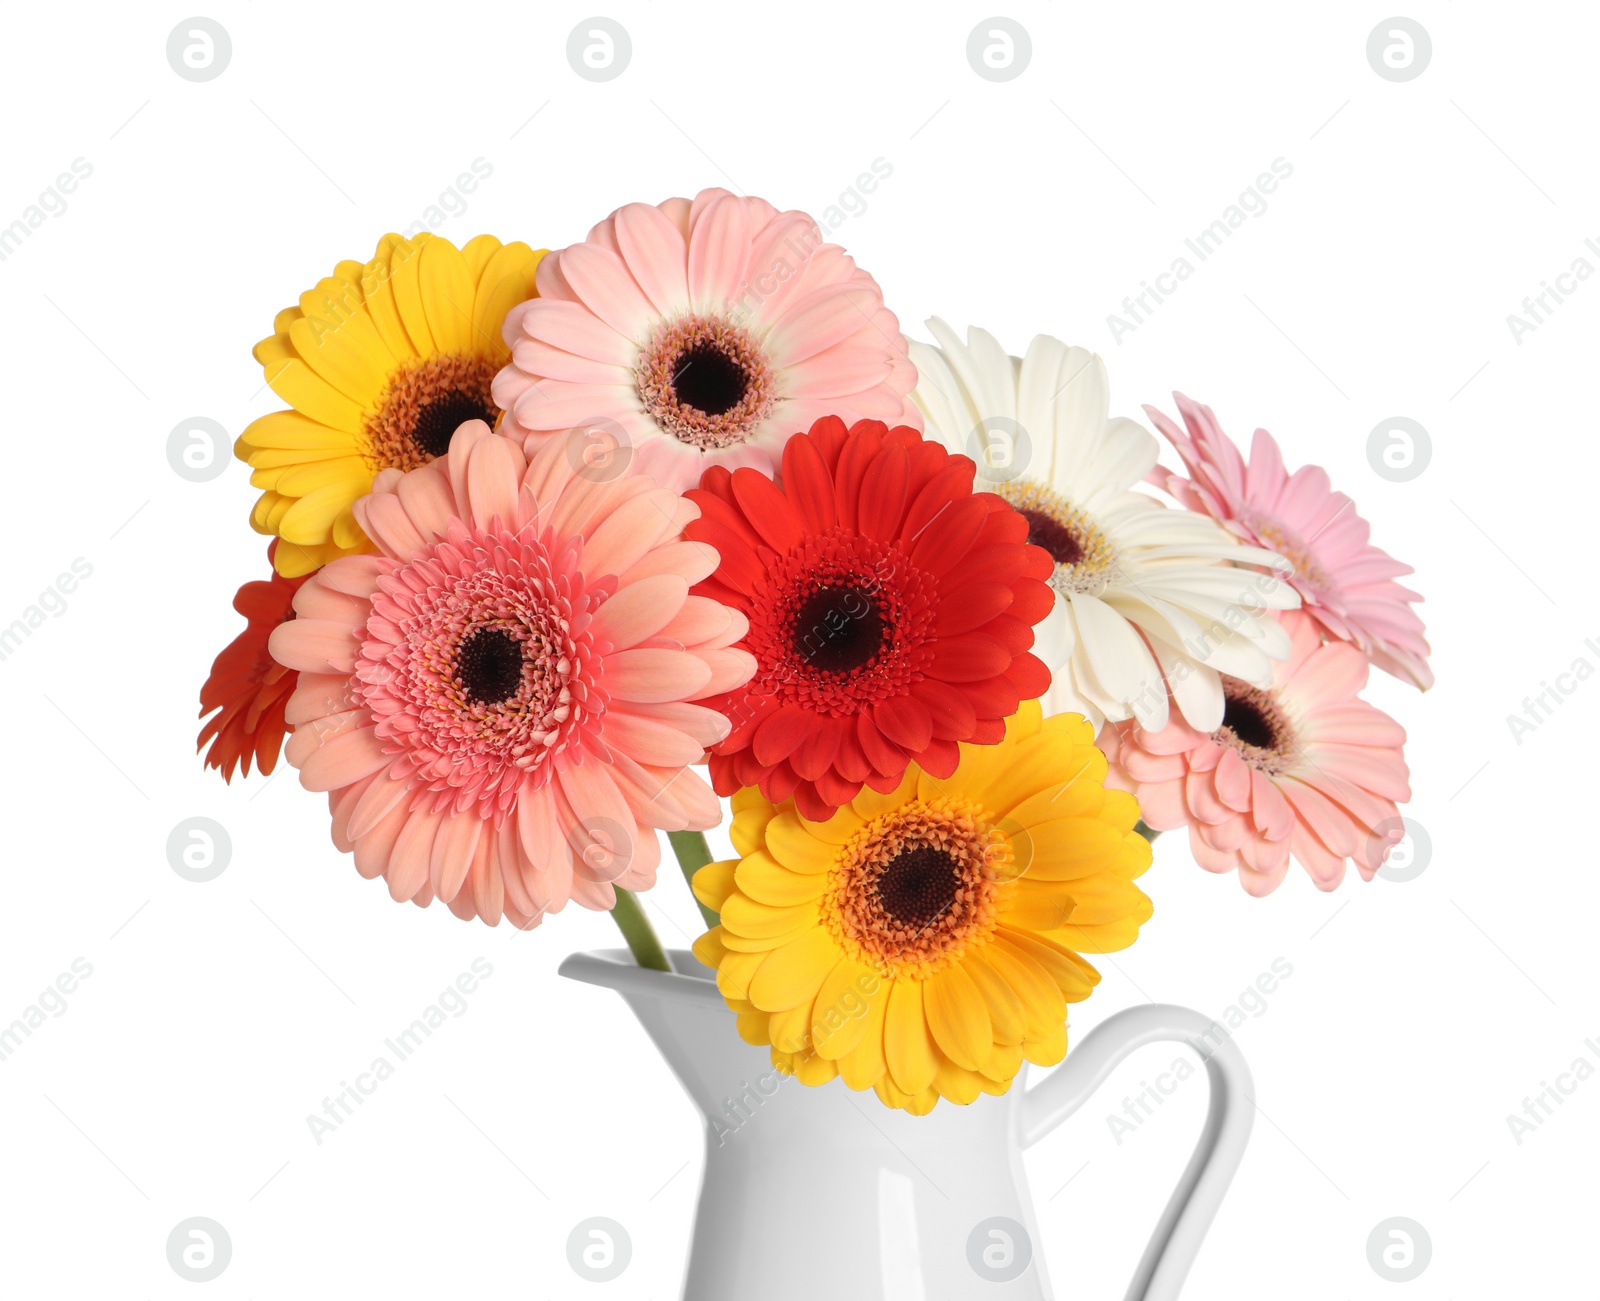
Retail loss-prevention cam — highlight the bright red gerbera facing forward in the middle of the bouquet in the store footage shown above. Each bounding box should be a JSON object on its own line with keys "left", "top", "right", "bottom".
{"left": 685, "top": 418, "right": 1051, "bottom": 819}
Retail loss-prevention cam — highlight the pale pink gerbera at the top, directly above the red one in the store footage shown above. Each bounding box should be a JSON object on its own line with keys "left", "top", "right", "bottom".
{"left": 493, "top": 189, "right": 917, "bottom": 490}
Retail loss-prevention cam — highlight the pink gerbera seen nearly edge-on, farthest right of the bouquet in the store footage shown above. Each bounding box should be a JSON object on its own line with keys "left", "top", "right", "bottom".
{"left": 1144, "top": 394, "right": 1434, "bottom": 690}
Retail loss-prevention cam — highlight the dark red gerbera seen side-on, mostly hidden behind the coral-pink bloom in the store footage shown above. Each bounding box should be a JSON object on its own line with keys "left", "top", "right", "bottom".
{"left": 195, "top": 539, "right": 304, "bottom": 781}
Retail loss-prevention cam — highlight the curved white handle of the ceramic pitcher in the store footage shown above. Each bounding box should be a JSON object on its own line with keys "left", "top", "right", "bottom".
{"left": 1021, "top": 1003, "right": 1256, "bottom": 1301}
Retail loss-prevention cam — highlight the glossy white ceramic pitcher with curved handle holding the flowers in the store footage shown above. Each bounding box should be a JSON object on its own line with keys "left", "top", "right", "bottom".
{"left": 560, "top": 949, "right": 1254, "bottom": 1301}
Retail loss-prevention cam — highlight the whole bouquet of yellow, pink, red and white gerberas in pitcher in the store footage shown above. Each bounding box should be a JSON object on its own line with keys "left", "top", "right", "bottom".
{"left": 200, "top": 182, "right": 1430, "bottom": 1114}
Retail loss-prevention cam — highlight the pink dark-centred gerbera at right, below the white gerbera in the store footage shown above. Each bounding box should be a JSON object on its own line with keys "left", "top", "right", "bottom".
{"left": 1098, "top": 610, "right": 1411, "bottom": 895}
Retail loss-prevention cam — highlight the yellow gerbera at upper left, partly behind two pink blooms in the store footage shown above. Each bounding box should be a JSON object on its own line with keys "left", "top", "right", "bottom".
{"left": 234, "top": 230, "right": 544, "bottom": 576}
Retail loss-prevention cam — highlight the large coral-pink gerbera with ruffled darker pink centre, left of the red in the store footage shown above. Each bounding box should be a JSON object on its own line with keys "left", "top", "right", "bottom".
{"left": 270, "top": 421, "right": 755, "bottom": 927}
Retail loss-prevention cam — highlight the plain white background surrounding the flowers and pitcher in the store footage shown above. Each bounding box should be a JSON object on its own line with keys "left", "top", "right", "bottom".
{"left": 0, "top": 0, "right": 1600, "bottom": 1301}
